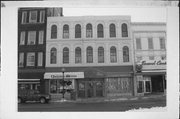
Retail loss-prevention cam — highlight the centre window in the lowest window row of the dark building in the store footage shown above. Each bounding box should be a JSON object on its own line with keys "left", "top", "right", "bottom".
{"left": 26, "top": 52, "right": 35, "bottom": 66}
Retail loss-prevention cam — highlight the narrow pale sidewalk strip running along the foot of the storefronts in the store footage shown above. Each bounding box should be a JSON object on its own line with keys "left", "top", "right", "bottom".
{"left": 50, "top": 94, "right": 166, "bottom": 103}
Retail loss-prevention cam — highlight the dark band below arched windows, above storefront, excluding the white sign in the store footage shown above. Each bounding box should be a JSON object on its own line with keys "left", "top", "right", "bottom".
{"left": 46, "top": 66, "right": 133, "bottom": 78}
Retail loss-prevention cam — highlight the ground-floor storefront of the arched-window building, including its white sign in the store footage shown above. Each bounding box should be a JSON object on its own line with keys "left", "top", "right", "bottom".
{"left": 44, "top": 66, "right": 133, "bottom": 99}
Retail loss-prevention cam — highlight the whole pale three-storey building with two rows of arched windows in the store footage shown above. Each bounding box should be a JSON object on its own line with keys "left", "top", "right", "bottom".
{"left": 44, "top": 16, "right": 134, "bottom": 99}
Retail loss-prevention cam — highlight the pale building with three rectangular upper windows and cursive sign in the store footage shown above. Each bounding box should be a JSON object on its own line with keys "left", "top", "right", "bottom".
{"left": 132, "top": 22, "right": 166, "bottom": 95}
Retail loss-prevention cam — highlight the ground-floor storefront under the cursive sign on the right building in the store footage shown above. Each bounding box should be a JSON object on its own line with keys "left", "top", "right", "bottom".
{"left": 135, "top": 61, "right": 166, "bottom": 95}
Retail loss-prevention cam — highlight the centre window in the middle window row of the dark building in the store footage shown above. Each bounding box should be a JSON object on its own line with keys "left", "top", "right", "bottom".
{"left": 27, "top": 31, "right": 36, "bottom": 45}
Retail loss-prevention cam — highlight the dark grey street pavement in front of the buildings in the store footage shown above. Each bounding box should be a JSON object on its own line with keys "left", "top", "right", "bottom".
{"left": 18, "top": 96, "right": 166, "bottom": 112}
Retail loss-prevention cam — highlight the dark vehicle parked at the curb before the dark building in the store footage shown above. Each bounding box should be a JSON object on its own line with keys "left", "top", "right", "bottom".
{"left": 18, "top": 89, "right": 51, "bottom": 103}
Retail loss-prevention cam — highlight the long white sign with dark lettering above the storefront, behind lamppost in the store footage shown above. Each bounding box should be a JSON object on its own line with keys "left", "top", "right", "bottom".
{"left": 44, "top": 72, "right": 84, "bottom": 79}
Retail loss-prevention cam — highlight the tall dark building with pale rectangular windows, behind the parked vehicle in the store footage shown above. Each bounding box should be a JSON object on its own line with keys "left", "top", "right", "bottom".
{"left": 18, "top": 7, "right": 62, "bottom": 93}
